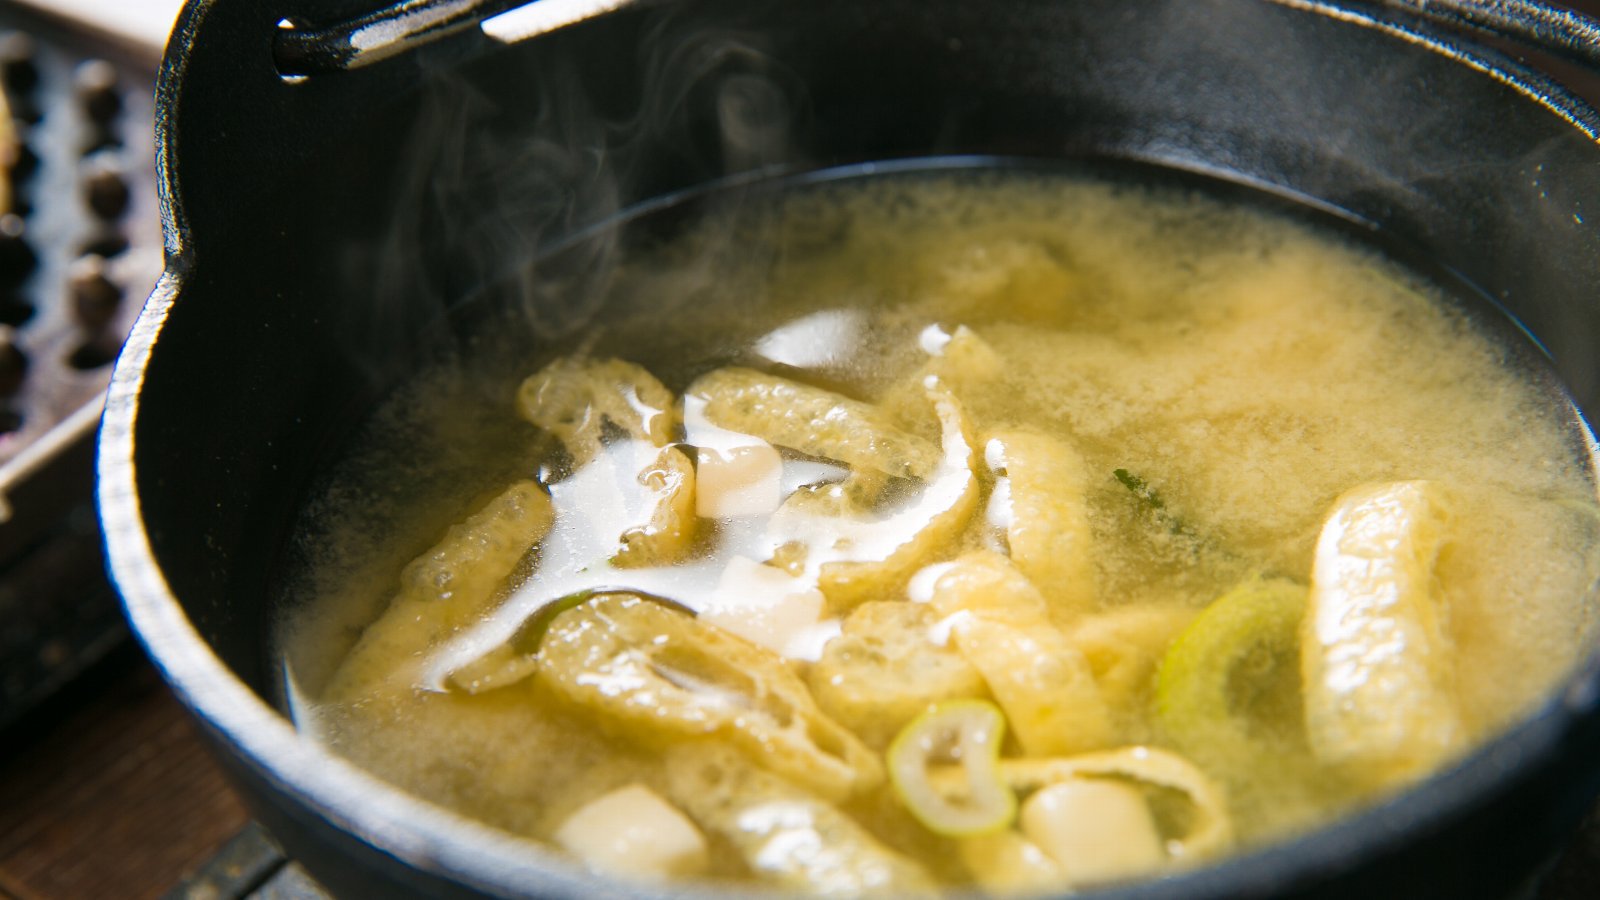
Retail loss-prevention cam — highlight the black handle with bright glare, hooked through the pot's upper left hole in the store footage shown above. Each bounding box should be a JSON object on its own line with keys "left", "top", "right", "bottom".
{"left": 272, "top": 0, "right": 627, "bottom": 78}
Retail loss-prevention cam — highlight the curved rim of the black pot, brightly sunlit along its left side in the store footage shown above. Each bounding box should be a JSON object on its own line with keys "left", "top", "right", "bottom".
{"left": 96, "top": 0, "right": 1600, "bottom": 900}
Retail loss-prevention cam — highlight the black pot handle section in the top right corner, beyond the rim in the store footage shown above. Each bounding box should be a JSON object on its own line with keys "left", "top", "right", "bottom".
{"left": 1382, "top": 0, "right": 1600, "bottom": 69}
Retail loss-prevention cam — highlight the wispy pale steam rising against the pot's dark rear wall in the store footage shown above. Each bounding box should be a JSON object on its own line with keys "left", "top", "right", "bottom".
{"left": 344, "top": 19, "right": 808, "bottom": 384}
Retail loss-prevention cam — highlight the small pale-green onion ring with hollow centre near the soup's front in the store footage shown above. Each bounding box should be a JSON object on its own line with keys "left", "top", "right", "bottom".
{"left": 888, "top": 700, "right": 1016, "bottom": 838}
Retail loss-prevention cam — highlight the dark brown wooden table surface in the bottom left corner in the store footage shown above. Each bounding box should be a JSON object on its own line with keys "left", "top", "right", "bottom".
{"left": 0, "top": 644, "right": 248, "bottom": 900}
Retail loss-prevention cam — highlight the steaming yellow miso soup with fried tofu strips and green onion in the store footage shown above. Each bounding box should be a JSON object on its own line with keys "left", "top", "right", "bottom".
{"left": 282, "top": 171, "right": 1600, "bottom": 895}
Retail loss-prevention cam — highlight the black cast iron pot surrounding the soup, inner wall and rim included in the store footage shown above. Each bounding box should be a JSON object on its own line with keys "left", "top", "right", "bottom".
{"left": 99, "top": 0, "right": 1600, "bottom": 898}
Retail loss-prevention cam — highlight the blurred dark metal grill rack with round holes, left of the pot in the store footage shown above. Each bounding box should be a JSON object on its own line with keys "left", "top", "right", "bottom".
{"left": 0, "top": 5, "right": 162, "bottom": 732}
